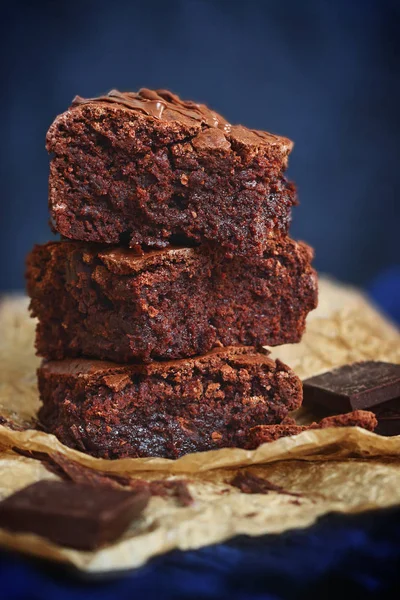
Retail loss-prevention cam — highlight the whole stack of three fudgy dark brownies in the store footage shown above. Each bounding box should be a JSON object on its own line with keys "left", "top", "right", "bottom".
{"left": 27, "top": 89, "right": 317, "bottom": 458}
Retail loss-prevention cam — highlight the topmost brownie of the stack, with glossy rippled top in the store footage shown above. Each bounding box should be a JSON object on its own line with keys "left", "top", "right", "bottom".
{"left": 47, "top": 89, "right": 296, "bottom": 255}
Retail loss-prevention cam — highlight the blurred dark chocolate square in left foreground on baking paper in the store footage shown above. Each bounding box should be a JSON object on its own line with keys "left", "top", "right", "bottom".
{"left": 0, "top": 481, "right": 149, "bottom": 550}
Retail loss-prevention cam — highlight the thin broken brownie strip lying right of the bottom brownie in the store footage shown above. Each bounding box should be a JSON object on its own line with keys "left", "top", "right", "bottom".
{"left": 246, "top": 410, "right": 378, "bottom": 449}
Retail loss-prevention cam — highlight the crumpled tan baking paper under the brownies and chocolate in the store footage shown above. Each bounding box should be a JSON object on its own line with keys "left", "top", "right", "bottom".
{"left": 0, "top": 279, "right": 400, "bottom": 573}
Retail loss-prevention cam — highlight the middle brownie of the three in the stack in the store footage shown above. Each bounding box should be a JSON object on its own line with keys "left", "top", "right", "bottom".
{"left": 27, "top": 238, "right": 317, "bottom": 362}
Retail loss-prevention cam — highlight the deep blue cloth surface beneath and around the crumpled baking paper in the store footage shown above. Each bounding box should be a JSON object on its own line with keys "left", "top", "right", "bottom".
{"left": 0, "top": 278, "right": 400, "bottom": 600}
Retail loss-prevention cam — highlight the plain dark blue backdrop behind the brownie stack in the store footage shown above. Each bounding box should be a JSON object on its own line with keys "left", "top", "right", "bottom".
{"left": 0, "top": 0, "right": 400, "bottom": 289}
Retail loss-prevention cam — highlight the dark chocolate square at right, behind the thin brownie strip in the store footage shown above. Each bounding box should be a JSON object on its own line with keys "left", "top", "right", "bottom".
{"left": 303, "top": 361, "right": 400, "bottom": 412}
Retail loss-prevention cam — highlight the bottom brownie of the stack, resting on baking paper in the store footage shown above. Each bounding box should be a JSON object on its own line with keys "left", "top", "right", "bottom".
{"left": 38, "top": 347, "right": 302, "bottom": 458}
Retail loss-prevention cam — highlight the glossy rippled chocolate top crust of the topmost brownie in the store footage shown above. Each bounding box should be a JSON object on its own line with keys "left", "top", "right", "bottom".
{"left": 72, "top": 88, "right": 293, "bottom": 153}
